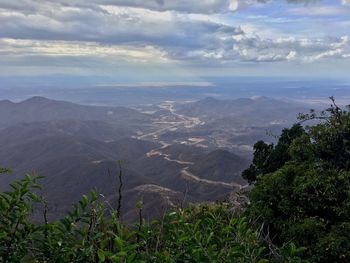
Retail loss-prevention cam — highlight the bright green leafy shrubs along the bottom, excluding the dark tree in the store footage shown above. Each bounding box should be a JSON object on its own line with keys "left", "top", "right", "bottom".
{"left": 0, "top": 176, "right": 306, "bottom": 263}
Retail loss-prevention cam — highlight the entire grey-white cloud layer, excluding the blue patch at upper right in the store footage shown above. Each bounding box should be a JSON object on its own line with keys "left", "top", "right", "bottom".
{"left": 0, "top": 0, "right": 350, "bottom": 72}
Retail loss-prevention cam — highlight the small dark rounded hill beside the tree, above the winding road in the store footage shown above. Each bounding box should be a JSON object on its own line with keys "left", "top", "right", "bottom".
{"left": 189, "top": 150, "right": 250, "bottom": 185}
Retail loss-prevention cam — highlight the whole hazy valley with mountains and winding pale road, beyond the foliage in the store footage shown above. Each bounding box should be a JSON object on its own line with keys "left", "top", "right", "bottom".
{"left": 0, "top": 97, "right": 318, "bottom": 221}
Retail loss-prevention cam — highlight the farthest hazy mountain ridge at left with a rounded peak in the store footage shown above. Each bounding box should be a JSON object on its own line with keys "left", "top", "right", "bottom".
{"left": 0, "top": 97, "right": 150, "bottom": 128}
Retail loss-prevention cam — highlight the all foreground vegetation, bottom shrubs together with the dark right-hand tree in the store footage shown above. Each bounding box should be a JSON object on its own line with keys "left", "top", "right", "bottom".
{"left": 0, "top": 98, "right": 350, "bottom": 263}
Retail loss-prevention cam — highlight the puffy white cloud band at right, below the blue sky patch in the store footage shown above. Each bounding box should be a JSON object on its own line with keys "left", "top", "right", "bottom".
{"left": 182, "top": 33, "right": 350, "bottom": 63}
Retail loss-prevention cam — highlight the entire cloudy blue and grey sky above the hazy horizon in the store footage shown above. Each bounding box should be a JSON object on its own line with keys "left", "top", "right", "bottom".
{"left": 0, "top": 0, "right": 350, "bottom": 85}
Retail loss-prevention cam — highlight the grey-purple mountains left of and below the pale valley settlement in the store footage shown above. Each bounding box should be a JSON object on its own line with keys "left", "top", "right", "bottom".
{"left": 0, "top": 97, "right": 254, "bottom": 221}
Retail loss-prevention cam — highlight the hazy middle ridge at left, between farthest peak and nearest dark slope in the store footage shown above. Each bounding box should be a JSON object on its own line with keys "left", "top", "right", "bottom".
{"left": 0, "top": 130, "right": 159, "bottom": 183}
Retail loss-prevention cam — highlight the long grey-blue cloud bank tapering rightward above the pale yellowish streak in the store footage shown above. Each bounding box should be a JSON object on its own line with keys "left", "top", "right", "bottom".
{"left": 0, "top": 3, "right": 240, "bottom": 50}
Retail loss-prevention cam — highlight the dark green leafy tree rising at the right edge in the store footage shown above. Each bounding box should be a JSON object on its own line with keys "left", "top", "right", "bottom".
{"left": 246, "top": 98, "right": 350, "bottom": 263}
